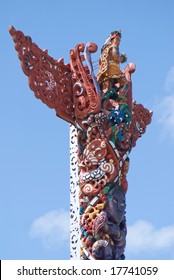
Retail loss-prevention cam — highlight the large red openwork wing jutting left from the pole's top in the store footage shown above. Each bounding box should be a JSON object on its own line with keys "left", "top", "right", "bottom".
{"left": 9, "top": 26, "right": 75, "bottom": 124}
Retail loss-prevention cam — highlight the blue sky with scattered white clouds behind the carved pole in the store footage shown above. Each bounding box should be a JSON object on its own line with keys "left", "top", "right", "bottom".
{"left": 0, "top": 0, "right": 174, "bottom": 260}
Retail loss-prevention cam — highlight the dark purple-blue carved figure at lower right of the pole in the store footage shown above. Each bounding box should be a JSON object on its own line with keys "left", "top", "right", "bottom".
{"left": 92, "top": 184, "right": 127, "bottom": 260}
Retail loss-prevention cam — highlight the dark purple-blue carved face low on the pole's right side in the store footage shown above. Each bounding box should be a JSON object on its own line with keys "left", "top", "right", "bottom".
{"left": 108, "top": 187, "right": 126, "bottom": 224}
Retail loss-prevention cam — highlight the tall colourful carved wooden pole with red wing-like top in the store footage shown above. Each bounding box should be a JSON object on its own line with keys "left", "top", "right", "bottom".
{"left": 9, "top": 26, "right": 152, "bottom": 260}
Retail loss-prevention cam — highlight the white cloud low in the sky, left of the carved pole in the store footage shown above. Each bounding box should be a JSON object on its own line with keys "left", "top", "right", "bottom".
{"left": 30, "top": 210, "right": 70, "bottom": 249}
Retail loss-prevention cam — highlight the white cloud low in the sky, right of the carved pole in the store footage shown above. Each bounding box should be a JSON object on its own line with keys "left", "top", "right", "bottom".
{"left": 126, "top": 220, "right": 174, "bottom": 255}
